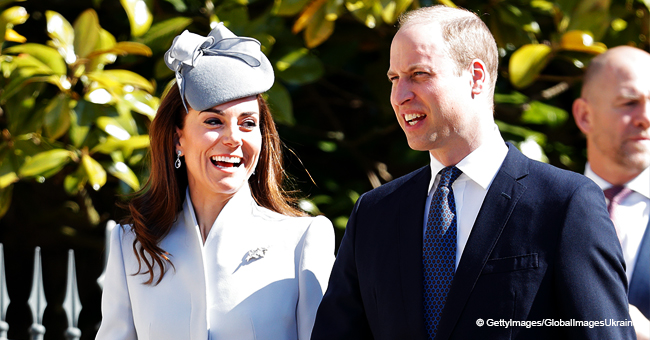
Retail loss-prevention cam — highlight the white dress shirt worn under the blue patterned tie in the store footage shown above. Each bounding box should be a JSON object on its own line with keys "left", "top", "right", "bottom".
{"left": 424, "top": 125, "right": 508, "bottom": 268}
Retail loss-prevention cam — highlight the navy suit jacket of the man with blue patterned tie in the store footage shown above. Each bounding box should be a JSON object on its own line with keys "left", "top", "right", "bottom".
{"left": 312, "top": 145, "right": 635, "bottom": 340}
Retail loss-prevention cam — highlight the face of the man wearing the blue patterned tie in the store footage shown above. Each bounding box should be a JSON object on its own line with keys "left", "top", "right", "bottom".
{"left": 388, "top": 24, "right": 478, "bottom": 152}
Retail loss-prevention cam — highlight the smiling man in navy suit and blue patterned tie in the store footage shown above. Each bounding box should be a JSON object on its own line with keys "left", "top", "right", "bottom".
{"left": 312, "top": 6, "right": 634, "bottom": 340}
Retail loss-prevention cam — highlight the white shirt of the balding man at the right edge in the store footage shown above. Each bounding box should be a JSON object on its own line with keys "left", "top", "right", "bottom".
{"left": 585, "top": 163, "right": 650, "bottom": 282}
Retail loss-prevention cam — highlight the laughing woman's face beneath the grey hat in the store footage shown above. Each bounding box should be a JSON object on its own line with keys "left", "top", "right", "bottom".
{"left": 176, "top": 96, "right": 262, "bottom": 199}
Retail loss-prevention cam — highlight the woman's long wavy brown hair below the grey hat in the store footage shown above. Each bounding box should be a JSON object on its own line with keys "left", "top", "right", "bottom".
{"left": 123, "top": 84, "right": 306, "bottom": 284}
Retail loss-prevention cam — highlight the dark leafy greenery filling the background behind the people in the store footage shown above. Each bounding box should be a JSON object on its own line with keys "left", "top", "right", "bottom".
{"left": 0, "top": 0, "right": 650, "bottom": 339}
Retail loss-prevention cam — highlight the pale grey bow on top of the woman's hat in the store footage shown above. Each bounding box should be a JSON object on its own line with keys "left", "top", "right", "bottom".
{"left": 165, "top": 23, "right": 262, "bottom": 112}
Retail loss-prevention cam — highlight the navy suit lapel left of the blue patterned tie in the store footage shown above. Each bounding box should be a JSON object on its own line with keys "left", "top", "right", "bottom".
{"left": 397, "top": 166, "right": 431, "bottom": 339}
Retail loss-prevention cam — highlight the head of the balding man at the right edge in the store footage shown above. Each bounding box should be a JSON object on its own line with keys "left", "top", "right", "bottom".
{"left": 584, "top": 58, "right": 650, "bottom": 173}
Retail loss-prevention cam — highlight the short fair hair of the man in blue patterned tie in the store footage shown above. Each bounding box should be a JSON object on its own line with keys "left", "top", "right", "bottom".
{"left": 399, "top": 5, "right": 499, "bottom": 91}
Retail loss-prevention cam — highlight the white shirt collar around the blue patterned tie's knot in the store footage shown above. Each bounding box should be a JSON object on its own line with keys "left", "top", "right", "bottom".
{"left": 429, "top": 124, "right": 508, "bottom": 192}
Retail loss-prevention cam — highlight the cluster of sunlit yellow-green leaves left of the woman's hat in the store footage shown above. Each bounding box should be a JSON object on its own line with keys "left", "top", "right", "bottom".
{"left": 0, "top": 1, "right": 156, "bottom": 218}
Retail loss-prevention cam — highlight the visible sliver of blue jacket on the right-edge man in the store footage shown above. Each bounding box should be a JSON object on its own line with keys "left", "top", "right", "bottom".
{"left": 628, "top": 222, "right": 650, "bottom": 318}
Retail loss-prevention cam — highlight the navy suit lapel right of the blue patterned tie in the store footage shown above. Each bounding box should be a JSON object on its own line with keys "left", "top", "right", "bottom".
{"left": 436, "top": 144, "right": 529, "bottom": 340}
